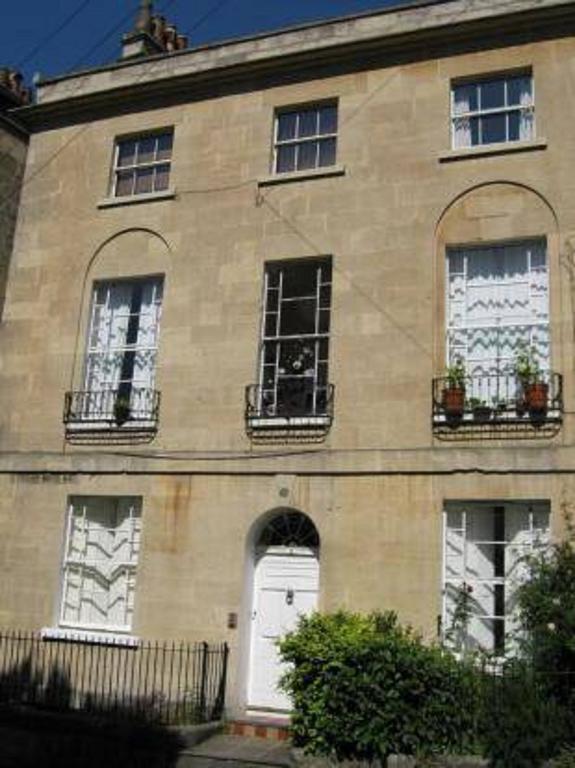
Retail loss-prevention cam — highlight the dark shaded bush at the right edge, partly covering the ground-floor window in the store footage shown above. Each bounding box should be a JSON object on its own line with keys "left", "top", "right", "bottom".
{"left": 482, "top": 518, "right": 575, "bottom": 768}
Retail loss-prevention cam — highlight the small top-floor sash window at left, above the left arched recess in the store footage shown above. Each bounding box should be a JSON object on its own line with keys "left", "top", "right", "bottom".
{"left": 112, "top": 131, "right": 174, "bottom": 197}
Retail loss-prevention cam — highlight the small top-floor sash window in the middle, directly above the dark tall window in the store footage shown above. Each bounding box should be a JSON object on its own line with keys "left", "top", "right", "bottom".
{"left": 274, "top": 102, "right": 337, "bottom": 173}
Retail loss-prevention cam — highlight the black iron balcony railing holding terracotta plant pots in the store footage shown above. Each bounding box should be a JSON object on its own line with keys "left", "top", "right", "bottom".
{"left": 432, "top": 371, "right": 563, "bottom": 436}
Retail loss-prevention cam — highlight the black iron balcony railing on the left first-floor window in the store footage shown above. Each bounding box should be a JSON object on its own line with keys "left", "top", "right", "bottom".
{"left": 64, "top": 387, "right": 160, "bottom": 432}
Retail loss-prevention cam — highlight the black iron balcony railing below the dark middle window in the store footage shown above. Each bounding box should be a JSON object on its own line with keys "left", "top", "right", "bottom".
{"left": 245, "top": 378, "right": 334, "bottom": 430}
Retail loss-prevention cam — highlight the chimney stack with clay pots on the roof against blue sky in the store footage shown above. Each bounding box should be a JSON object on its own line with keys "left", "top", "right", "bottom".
{"left": 121, "top": 0, "right": 188, "bottom": 61}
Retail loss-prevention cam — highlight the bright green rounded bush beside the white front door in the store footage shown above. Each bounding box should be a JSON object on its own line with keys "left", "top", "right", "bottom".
{"left": 280, "top": 612, "right": 477, "bottom": 760}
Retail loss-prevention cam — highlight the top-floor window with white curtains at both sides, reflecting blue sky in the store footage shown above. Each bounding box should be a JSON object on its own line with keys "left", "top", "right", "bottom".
{"left": 451, "top": 73, "right": 535, "bottom": 149}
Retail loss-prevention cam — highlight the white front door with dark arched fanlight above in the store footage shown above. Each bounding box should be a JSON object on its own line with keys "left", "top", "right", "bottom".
{"left": 244, "top": 507, "right": 320, "bottom": 713}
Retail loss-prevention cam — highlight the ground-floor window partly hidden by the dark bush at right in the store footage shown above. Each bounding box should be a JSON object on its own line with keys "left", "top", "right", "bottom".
{"left": 443, "top": 501, "right": 550, "bottom": 655}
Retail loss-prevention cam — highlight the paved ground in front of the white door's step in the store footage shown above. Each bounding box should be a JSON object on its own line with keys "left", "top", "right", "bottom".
{"left": 177, "top": 735, "right": 292, "bottom": 768}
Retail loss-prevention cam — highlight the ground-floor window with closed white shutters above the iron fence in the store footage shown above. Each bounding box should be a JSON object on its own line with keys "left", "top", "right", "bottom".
{"left": 60, "top": 496, "right": 142, "bottom": 631}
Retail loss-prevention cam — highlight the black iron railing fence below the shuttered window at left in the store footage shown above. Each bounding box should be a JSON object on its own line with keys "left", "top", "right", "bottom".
{"left": 0, "top": 631, "right": 229, "bottom": 725}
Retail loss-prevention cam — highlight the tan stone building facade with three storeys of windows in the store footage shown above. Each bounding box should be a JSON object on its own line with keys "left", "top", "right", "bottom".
{"left": 0, "top": 0, "right": 575, "bottom": 712}
